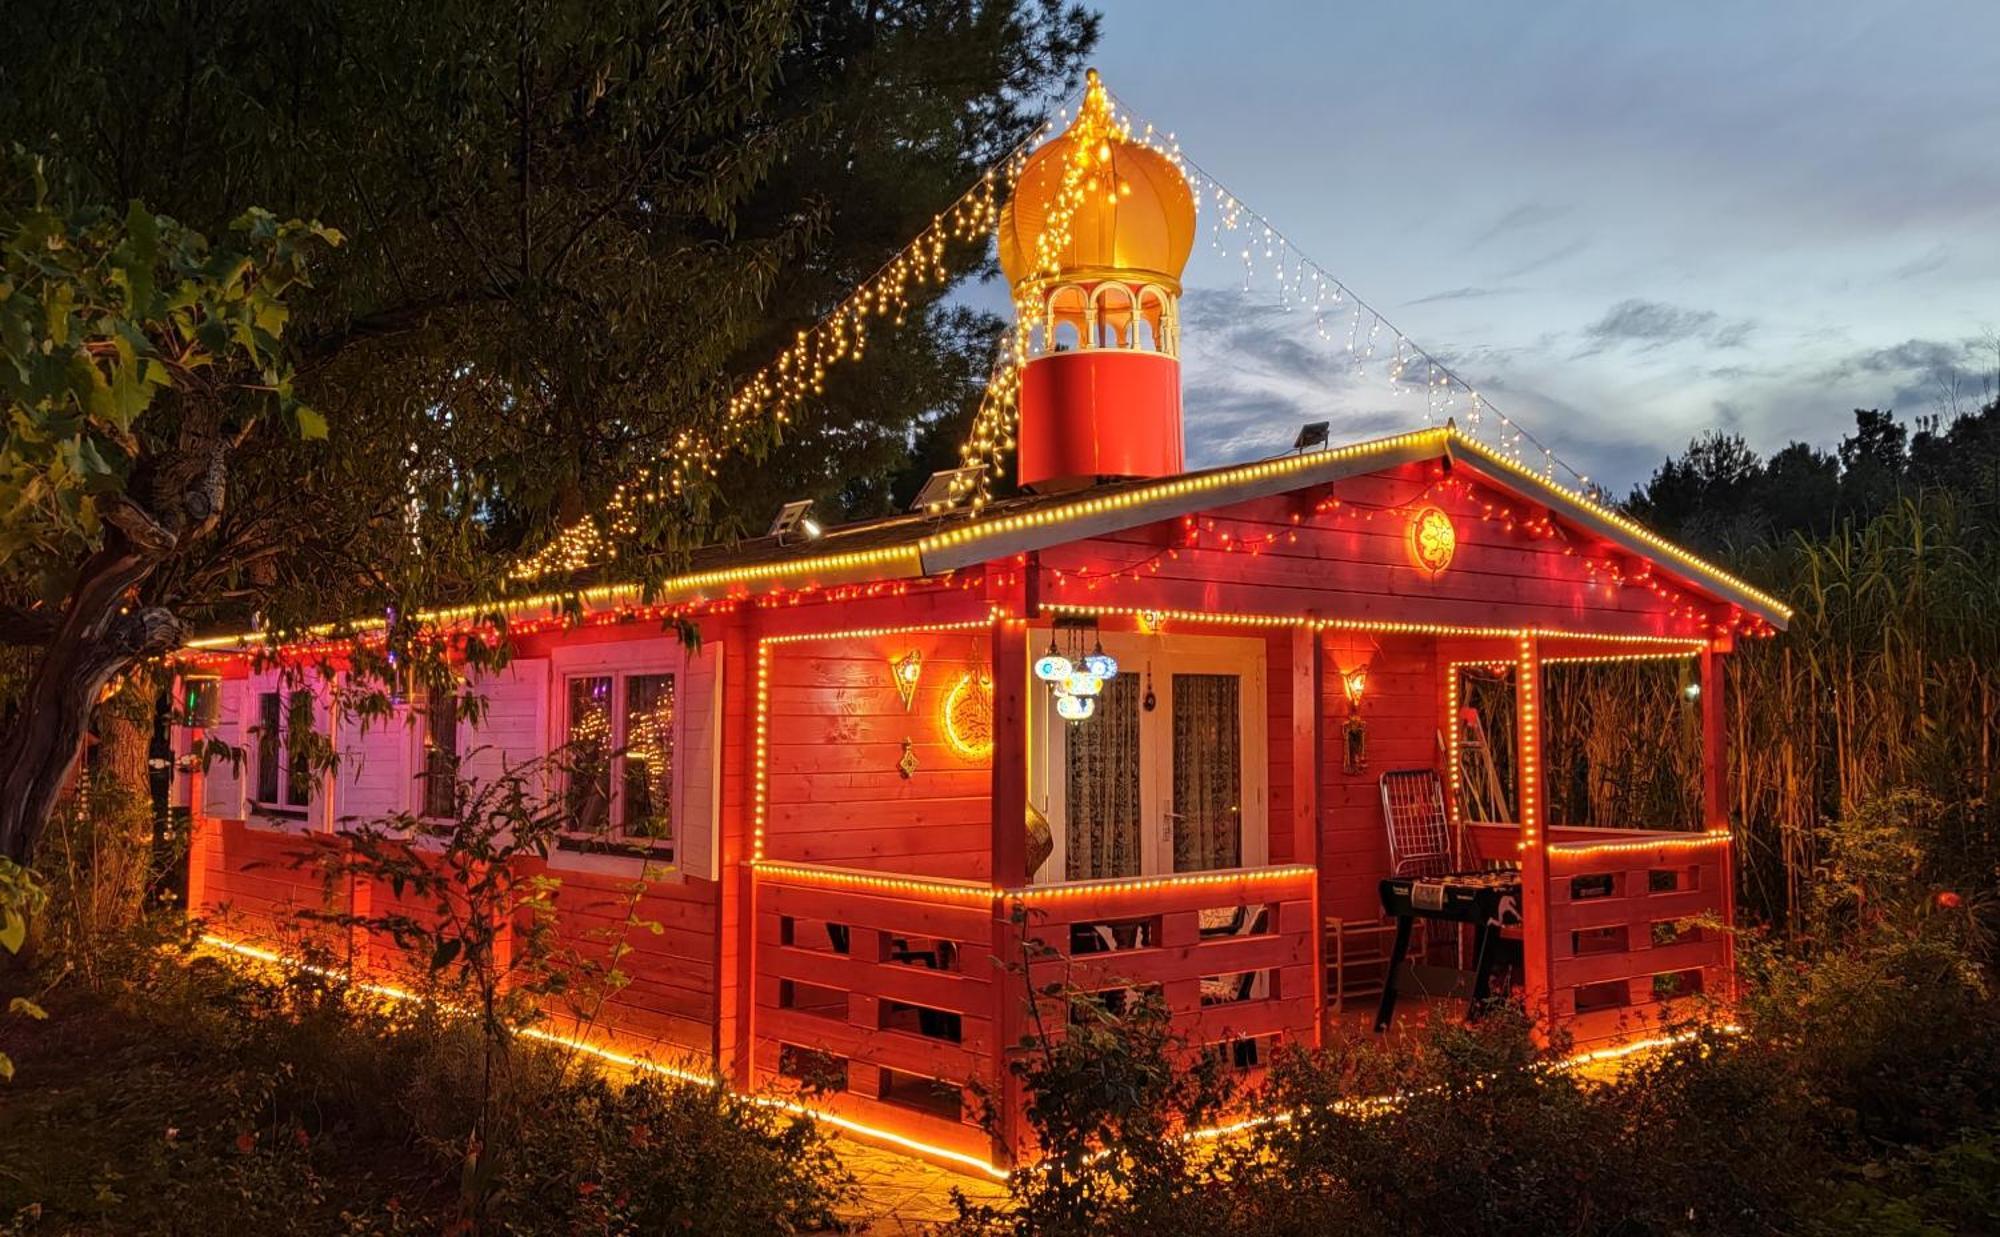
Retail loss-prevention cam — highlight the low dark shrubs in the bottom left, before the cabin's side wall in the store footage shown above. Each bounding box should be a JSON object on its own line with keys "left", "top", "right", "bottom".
{"left": 0, "top": 928, "right": 844, "bottom": 1233}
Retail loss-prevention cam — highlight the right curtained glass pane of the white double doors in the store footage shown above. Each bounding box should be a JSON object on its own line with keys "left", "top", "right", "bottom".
{"left": 1174, "top": 675, "right": 1244, "bottom": 873}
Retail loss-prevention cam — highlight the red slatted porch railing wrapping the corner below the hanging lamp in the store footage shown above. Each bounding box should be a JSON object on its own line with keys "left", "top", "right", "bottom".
{"left": 752, "top": 863, "right": 1318, "bottom": 1155}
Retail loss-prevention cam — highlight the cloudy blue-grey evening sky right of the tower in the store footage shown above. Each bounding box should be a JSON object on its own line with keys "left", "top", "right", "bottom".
{"left": 1024, "top": 0, "right": 2000, "bottom": 494}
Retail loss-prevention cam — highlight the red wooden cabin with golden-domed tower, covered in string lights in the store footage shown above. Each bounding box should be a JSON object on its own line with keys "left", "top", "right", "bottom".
{"left": 184, "top": 72, "right": 1788, "bottom": 1167}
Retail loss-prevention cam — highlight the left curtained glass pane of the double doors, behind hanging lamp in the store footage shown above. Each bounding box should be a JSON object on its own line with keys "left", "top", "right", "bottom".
{"left": 1058, "top": 675, "right": 1140, "bottom": 881}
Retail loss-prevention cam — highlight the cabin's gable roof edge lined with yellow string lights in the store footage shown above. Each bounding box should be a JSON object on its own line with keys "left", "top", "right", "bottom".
{"left": 190, "top": 424, "right": 1792, "bottom": 649}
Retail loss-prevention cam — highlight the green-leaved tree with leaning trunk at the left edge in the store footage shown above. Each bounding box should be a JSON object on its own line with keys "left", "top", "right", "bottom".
{"left": 0, "top": 166, "right": 340, "bottom": 861}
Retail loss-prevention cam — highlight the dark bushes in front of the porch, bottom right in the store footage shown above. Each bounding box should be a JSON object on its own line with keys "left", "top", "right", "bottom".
{"left": 960, "top": 795, "right": 2000, "bottom": 1237}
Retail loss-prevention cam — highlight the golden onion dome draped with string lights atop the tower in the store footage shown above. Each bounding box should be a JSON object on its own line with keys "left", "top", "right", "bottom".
{"left": 1000, "top": 70, "right": 1194, "bottom": 292}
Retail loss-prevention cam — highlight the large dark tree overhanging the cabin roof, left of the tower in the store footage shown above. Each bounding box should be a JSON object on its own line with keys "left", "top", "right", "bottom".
{"left": 0, "top": 0, "right": 1096, "bottom": 856}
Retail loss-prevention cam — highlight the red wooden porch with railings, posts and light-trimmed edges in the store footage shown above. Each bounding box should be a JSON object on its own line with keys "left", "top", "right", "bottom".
{"left": 736, "top": 612, "right": 1730, "bottom": 1165}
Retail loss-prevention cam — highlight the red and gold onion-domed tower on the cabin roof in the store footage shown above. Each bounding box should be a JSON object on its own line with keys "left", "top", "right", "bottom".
{"left": 1000, "top": 70, "right": 1194, "bottom": 492}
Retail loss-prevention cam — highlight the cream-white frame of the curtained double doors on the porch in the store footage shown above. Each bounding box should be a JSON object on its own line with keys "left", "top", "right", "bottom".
{"left": 1028, "top": 629, "right": 1270, "bottom": 885}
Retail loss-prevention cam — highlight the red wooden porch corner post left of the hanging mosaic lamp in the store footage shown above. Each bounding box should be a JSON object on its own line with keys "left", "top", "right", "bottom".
{"left": 990, "top": 612, "right": 1028, "bottom": 1167}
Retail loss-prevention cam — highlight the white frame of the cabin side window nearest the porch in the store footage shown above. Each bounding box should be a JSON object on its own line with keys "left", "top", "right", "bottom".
{"left": 548, "top": 639, "right": 688, "bottom": 871}
